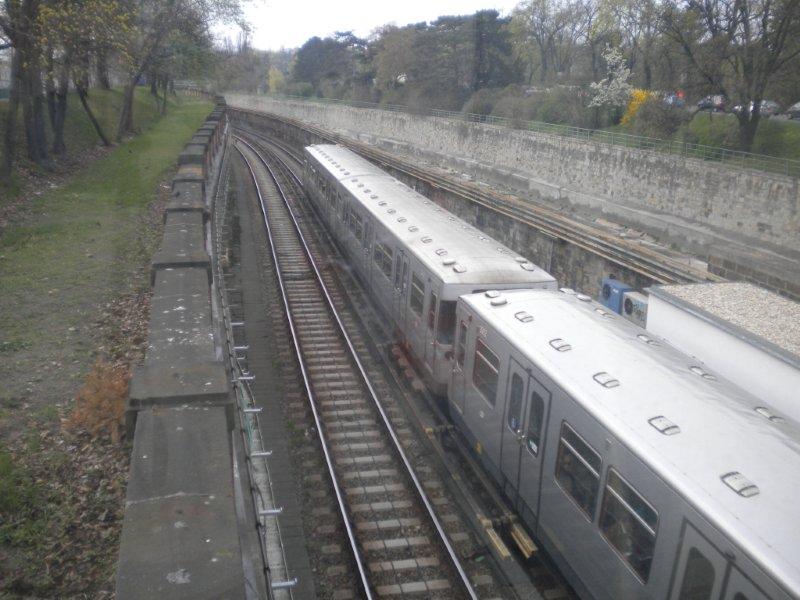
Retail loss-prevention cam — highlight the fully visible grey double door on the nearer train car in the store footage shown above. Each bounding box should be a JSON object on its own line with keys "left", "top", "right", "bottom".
{"left": 501, "top": 358, "right": 550, "bottom": 517}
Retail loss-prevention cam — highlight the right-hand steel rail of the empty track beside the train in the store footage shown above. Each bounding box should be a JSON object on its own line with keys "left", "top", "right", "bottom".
{"left": 234, "top": 136, "right": 478, "bottom": 600}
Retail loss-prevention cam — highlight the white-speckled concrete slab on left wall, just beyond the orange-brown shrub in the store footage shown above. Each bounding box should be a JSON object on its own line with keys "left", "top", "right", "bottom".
{"left": 145, "top": 268, "right": 215, "bottom": 365}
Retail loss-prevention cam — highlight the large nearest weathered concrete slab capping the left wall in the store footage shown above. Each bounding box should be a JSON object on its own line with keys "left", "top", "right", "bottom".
{"left": 117, "top": 407, "right": 245, "bottom": 600}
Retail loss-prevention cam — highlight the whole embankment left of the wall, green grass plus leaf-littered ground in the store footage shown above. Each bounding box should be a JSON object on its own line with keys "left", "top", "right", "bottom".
{"left": 0, "top": 91, "right": 211, "bottom": 597}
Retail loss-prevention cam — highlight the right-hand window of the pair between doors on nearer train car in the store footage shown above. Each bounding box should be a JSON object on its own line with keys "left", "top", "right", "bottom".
{"left": 600, "top": 469, "right": 658, "bottom": 581}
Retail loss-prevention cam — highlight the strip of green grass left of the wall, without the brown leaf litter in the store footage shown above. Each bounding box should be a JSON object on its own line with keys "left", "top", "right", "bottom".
{"left": 0, "top": 94, "right": 211, "bottom": 404}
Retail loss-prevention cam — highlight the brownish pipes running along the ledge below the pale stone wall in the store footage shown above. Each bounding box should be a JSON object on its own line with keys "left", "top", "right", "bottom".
{"left": 233, "top": 108, "right": 724, "bottom": 283}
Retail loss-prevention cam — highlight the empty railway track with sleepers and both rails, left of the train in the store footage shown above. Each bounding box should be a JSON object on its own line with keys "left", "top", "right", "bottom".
{"left": 234, "top": 137, "right": 478, "bottom": 598}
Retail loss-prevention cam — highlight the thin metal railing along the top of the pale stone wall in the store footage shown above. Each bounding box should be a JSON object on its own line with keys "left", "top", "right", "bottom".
{"left": 258, "top": 94, "right": 800, "bottom": 177}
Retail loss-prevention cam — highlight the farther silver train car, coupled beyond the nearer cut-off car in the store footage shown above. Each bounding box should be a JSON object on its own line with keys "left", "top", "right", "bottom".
{"left": 304, "top": 145, "right": 556, "bottom": 396}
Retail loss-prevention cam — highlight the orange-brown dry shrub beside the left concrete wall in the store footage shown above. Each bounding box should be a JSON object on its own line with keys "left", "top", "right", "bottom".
{"left": 68, "top": 359, "right": 129, "bottom": 443}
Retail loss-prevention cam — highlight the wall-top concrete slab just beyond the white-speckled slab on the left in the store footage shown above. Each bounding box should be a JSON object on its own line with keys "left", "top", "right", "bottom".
{"left": 151, "top": 211, "right": 211, "bottom": 284}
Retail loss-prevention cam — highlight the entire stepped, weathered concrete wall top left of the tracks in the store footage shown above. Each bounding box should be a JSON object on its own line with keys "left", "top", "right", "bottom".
{"left": 116, "top": 100, "right": 245, "bottom": 600}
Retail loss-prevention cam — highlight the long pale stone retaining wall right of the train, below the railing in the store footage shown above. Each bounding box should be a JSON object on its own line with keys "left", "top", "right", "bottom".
{"left": 226, "top": 94, "right": 800, "bottom": 253}
